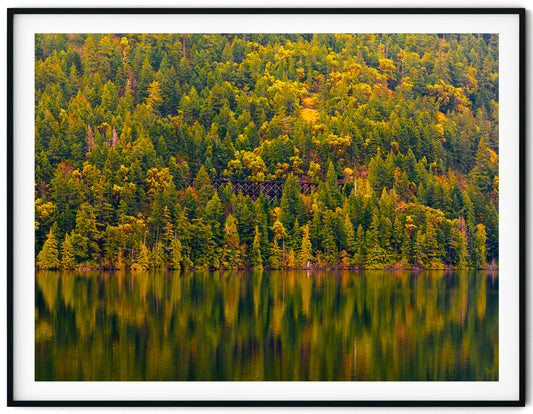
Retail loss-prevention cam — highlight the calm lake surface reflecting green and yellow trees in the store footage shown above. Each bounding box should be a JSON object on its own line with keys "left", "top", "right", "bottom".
{"left": 35, "top": 271, "right": 498, "bottom": 381}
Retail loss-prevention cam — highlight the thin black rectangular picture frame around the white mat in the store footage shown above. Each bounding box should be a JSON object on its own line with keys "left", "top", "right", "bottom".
{"left": 7, "top": 8, "right": 526, "bottom": 407}
